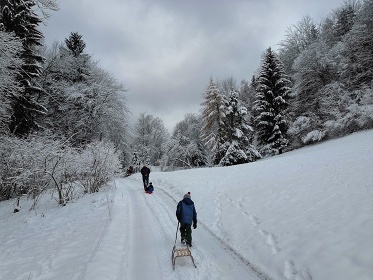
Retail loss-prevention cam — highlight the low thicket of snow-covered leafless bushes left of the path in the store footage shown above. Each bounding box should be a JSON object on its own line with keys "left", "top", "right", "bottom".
{"left": 0, "top": 135, "right": 120, "bottom": 207}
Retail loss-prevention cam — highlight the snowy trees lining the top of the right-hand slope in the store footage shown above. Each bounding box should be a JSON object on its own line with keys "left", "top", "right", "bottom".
{"left": 127, "top": 0, "right": 373, "bottom": 167}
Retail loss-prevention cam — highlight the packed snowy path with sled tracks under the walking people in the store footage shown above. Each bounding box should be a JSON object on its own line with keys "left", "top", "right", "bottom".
{"left": 108, "top": 178, "right": 258, "bottom": 280}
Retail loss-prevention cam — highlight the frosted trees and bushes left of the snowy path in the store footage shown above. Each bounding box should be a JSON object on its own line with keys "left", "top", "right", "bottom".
{"left": 0, "top": 0, "right": 128, "bottom": 205}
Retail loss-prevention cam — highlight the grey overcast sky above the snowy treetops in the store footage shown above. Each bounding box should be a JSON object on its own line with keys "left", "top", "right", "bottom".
{"left": 41, "top": 0, "right": 344, "bottom": 132}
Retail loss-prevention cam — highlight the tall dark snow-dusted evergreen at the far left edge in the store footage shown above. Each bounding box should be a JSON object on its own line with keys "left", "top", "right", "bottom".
{"left": 1, "top": 0, "right": 46, "bottom": 136}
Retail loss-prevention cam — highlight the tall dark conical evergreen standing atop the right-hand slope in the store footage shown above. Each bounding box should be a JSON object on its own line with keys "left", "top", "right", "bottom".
{"left": 253, "top": 48, "right": 290, "bottom": 154}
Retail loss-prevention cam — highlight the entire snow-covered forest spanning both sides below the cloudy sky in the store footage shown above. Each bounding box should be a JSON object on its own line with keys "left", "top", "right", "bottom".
{"left": 0, "top": 0, "right": 373, "bottom": 207}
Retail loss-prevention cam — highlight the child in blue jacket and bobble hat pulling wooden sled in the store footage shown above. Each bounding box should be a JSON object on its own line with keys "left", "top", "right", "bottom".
{"left": 176, "top": 192, "right": 197, "bottom": 246}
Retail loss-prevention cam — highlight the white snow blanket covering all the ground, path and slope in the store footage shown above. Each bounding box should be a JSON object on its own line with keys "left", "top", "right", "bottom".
{"left": 0, "top": 130, "right": 373, "bottom": 280}
